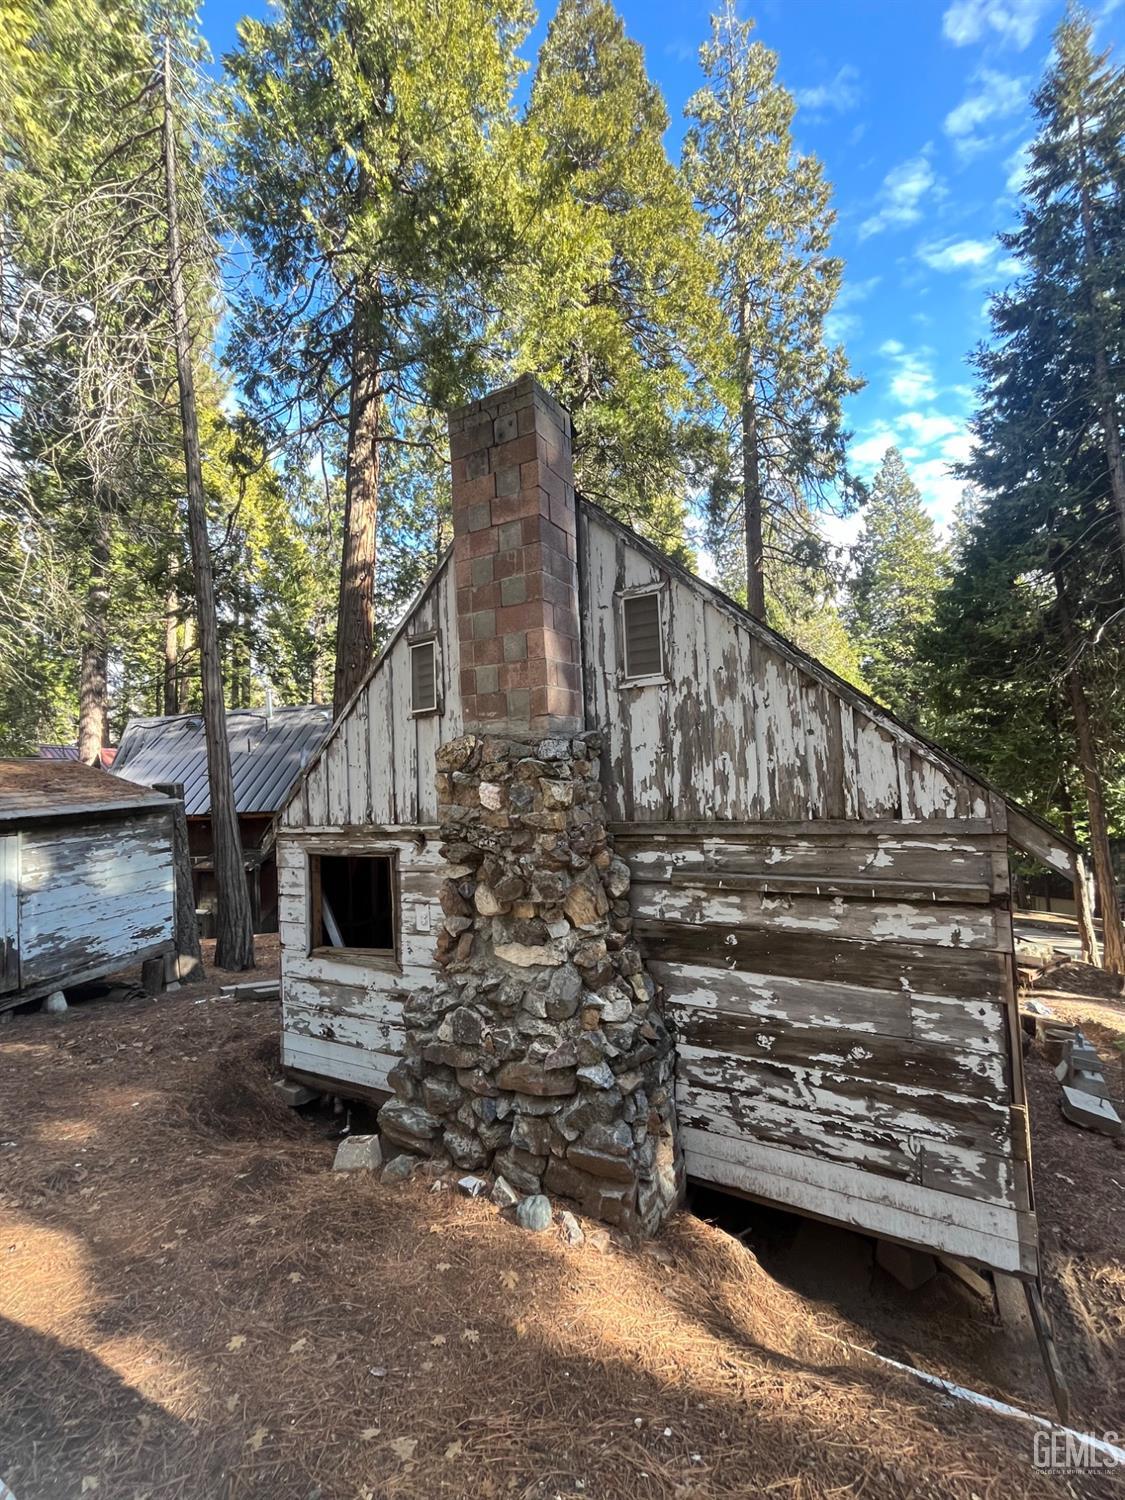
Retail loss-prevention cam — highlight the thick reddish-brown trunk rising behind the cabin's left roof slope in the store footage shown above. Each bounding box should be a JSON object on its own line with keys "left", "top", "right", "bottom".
{"left": 332, "top": 306, "right": 383, "bottom": 719}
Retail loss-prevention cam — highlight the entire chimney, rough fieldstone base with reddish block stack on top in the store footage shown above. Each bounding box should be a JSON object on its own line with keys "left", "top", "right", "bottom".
{"left": 380, "top": 380, "right": 683, "bottom": 1233}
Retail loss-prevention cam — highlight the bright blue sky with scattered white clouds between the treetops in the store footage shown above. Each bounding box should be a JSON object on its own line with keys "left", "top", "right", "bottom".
{"left": 203, "top": 0, "right": 1125, "bottom": 540}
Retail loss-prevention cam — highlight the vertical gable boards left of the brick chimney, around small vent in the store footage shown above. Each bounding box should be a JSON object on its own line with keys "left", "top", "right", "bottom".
{"left": 281, "top": 563, "right": 461, "bottom": 828}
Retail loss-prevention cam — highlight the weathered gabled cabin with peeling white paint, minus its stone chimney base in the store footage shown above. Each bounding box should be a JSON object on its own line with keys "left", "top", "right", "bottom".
{"left": 278, "top": 381, "right": 1073, "bottom": 1277}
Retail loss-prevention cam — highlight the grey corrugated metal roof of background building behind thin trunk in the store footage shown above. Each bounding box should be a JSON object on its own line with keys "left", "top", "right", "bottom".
{"left": 113, "top": 704, "right": 332, "bottom": 818}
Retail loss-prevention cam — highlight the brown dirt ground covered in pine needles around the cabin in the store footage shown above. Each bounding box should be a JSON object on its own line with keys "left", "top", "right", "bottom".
{"left": 0, "top": 944, "right": 1125, "bottom": 1500}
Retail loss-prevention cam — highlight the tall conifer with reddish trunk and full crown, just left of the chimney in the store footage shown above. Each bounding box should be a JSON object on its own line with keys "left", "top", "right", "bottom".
{"left": 227, "top": 0, "right": 528, "bottom": 711}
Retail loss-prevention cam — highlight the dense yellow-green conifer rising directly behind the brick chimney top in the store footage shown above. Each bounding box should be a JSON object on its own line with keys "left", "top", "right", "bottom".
{"left": 510, "top": 0, "right": 719, "bottom": 552}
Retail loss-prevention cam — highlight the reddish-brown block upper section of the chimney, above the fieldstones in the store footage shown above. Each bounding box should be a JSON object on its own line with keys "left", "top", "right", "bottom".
{"left": 449, "top": 375, "right": 585, "bottom": 737}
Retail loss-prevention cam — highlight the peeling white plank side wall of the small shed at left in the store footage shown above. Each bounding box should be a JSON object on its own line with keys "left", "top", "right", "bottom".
{"left": 18, "top": 810, "right": 174, "bottom": 990}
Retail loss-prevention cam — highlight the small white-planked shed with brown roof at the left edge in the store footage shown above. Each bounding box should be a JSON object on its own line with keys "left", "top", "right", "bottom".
{"left": 0, "top": 761, "right": 174, "bottom": 1010}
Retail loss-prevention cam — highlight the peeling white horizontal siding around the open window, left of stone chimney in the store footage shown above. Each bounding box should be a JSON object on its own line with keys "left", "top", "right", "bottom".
{"left": 278, "top": 825, "right": 444, "bottom": 1092}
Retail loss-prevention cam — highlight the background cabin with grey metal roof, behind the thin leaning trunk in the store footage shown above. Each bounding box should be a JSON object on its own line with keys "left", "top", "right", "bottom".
{"left": 114, "top": 704, "right": 332, "bottom": 938}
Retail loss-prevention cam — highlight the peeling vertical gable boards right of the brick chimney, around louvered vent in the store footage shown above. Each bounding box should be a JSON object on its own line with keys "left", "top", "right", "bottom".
{"left": 579, "top": 507, "right": 987, "bottom": 822}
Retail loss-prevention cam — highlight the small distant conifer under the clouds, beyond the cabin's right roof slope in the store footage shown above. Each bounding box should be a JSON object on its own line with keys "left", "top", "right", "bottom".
{"left": 848, "top": 449, "right": 948, "bottom": 723}
